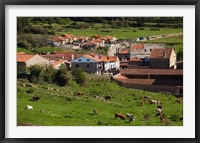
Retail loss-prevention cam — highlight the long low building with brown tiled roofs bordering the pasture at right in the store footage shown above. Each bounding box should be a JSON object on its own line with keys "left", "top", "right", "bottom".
{"left": 114, "top": 69, "right": 183, "bottom": 96}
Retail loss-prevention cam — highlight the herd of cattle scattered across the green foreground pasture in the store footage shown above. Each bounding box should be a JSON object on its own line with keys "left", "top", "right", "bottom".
{"left": 26, "top": 92, "right": 183, "bottom": 123}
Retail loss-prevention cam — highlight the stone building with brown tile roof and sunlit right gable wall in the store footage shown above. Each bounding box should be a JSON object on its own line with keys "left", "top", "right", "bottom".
{"left": 149, "top": 48, "right": 177, "bottom": 69}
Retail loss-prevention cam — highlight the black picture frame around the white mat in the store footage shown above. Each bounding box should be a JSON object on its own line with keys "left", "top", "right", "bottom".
{"left": 0, "top": 0, "right": 200, "bottom": 143}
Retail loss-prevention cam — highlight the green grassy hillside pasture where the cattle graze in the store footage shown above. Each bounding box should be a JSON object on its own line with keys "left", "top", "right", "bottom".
{"left": 17, "top": 80, "right": 183, "bottom": 126}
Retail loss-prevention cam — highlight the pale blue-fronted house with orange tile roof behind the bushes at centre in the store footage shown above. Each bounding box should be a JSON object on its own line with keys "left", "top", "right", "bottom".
{"left": 71, "top": 55, "right": 103, "bottom": 75}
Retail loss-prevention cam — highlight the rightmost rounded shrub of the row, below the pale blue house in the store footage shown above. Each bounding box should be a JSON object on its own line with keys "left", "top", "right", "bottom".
{"left": 72, "top": 68, "right": 86, "bottom": 85}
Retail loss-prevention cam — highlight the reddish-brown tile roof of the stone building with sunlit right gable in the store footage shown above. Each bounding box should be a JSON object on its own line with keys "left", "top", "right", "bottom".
{"left": 149, "top": 48, "right": 172, "bottom": 58}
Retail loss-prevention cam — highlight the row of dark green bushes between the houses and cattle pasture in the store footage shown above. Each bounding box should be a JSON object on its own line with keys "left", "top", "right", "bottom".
{"left": 18, "top": 65, "right": 86, "bottom": 86}
